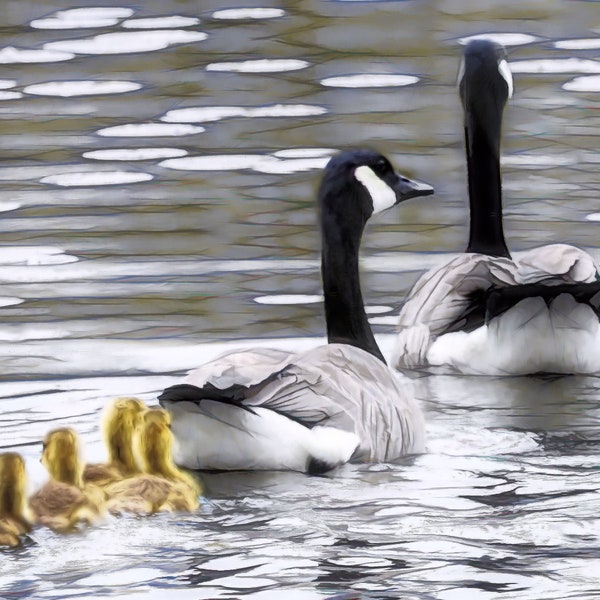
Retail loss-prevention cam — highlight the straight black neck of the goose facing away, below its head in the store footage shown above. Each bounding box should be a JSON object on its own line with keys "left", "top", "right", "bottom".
{"left": 465, "top": 113, "right": 510, "bottom": 258}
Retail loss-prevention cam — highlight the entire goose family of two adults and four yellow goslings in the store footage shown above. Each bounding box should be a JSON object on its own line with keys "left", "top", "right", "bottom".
{"left": 0, "top": 40, "right": 600, "bottom": 545}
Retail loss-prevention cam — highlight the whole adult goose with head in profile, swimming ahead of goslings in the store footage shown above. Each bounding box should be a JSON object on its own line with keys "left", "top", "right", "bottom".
{"left": 159, "top": 150, "right": 433, "bottom": 474}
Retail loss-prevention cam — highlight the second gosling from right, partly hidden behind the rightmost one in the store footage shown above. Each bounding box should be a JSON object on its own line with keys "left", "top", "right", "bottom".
{"left": 83, "top": 398, "right": 146, "bottom": 487}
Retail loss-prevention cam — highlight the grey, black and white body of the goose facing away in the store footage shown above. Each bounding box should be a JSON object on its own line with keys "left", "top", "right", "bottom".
{"left": 392, "top": 252, "right": 600, "bottom": 375}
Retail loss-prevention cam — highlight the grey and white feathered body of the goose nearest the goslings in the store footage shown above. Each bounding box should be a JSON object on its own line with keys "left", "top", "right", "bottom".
{"left": 159, "top": 344, "right": 425, "bottom": 471}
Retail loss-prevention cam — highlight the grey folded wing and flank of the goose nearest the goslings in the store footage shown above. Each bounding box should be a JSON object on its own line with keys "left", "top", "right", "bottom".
{"left": 243, "top": 344, "right": 425, "bottom": 462}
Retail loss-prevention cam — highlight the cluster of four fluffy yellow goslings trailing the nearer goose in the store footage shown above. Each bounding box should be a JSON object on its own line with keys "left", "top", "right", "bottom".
{"left": 0, "top": 398, "right": 201, "bottom": 546}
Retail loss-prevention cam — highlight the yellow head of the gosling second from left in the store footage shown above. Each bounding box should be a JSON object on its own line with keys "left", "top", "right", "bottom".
{"left": 42, "top": 427, "right": 83, "bottom": 487}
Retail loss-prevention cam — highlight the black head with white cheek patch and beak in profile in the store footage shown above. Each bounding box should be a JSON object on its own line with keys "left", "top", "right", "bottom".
{"left": 319, "top": 150, "right": 433, "bottom": 231}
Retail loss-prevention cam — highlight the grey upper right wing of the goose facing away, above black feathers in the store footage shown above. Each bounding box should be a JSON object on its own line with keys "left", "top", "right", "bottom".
{"left": 516, "top": 244, "right": 598, "bottom": 285}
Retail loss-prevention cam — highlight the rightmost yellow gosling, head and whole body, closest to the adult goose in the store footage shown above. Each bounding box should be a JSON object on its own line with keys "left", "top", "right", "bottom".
{"left": 104, "top": 408, "right": 200, "bottom": 514}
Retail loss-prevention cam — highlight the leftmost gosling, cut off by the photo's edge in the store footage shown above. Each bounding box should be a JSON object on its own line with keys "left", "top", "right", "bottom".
{"left": 0, "top": 452, "right": 31, "bottom": 546}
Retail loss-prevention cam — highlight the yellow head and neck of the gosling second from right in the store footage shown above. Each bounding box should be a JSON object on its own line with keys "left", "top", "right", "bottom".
{"left": 103, "top": 398, "right": 146, "bottom": 473}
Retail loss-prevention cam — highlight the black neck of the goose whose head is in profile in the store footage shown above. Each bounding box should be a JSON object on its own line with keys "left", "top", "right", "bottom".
{"left": 321, "top": 208, "right": 385, "bottom": 364}
